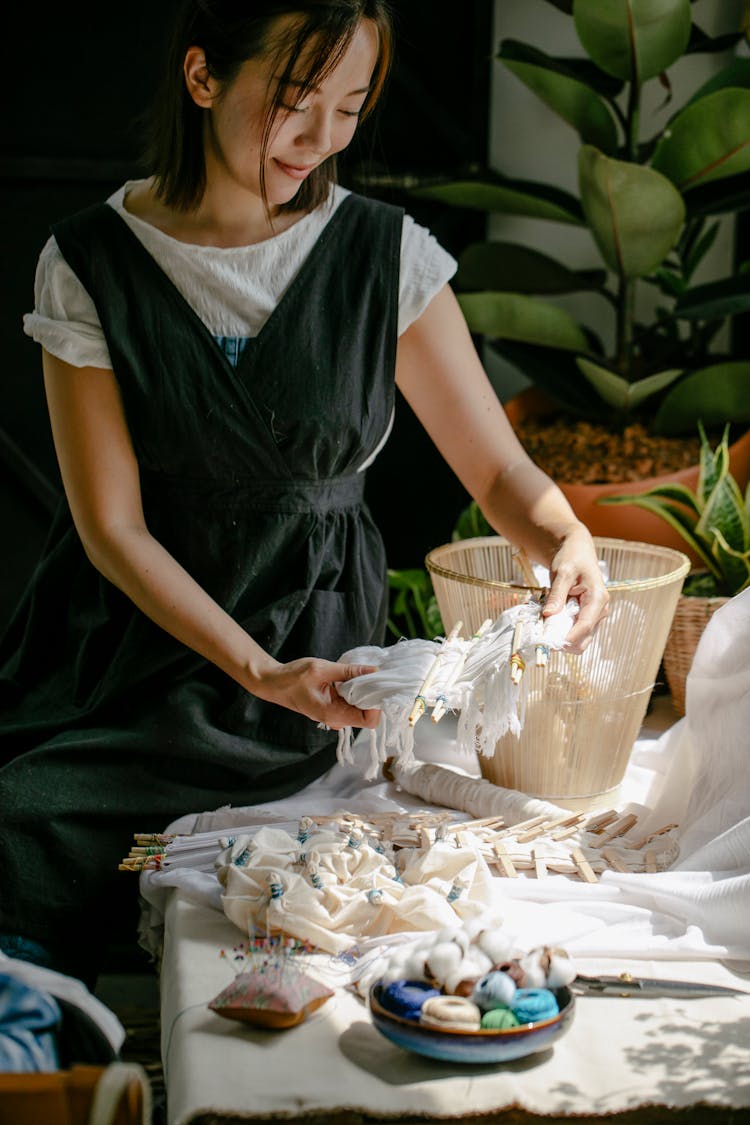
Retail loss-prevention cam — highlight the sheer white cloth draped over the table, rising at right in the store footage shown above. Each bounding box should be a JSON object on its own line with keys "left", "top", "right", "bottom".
{"left": 141, "top": 590, "right": 750, "bottom": 963}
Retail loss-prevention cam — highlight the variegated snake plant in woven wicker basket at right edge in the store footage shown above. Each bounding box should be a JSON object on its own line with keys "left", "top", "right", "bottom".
{"left": 602, "top": 423, "right": 750, "bottom": 714}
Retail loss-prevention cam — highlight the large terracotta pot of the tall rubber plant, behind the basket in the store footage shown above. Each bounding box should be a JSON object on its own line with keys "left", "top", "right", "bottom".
{"left": 505, "top": 387, "right": 750, "bottom": 565}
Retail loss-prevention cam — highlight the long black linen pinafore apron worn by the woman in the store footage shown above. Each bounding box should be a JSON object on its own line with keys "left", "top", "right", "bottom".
{"left": 0, "top": 195, "right": 403, "bottom": 976}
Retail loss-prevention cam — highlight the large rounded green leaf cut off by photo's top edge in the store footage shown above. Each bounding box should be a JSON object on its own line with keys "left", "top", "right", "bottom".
{"left": 573, "top": 0, "right": 692, "bottom": 82}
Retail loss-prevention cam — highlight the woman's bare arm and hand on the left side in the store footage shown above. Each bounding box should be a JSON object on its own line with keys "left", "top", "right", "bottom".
{"left": 43, "top": 351, "right": 378, "bottom": 728}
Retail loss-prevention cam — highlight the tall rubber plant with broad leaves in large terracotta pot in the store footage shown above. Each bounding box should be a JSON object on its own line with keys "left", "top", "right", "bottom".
{"left": 413, "top": 0, "right": 750, "bottom": 546}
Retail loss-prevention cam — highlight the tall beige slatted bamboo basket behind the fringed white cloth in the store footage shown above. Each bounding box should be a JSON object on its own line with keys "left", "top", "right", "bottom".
{"left": 425, "top": 536, "right": 690, "bottom": 808}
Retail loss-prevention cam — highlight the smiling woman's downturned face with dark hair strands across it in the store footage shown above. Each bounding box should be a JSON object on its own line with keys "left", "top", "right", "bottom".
{"left": 199, "top": 20, "right": 379, "bottom": 207}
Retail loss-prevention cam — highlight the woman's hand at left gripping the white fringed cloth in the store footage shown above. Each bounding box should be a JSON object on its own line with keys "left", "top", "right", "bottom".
{"left": 250, "top": 656, "right": 380, "bottom": 730}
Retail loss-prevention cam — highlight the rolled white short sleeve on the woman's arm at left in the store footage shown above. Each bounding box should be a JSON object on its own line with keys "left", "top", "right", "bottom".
{"left": 24, "top": 237, "right": 112, "bottom": 369}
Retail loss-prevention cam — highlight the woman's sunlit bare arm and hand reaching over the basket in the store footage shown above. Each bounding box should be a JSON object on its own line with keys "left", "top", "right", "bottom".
{"left": 396, "top": 286, "right": 607, "bottom": 650}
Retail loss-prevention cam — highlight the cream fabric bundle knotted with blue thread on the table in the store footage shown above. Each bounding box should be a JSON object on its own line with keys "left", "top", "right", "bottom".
{"left": 216, "top": 827, "right": 501, "bottom": 954}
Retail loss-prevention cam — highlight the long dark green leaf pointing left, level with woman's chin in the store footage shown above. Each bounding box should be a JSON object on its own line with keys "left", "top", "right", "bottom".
{"left": 410, "top": 179, "right": 584, "bottom": 226}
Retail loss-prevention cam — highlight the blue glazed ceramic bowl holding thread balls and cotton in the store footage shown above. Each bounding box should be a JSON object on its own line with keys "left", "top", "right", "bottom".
{"left": 368, "top": 981, "right": 576, "bottom": 1063}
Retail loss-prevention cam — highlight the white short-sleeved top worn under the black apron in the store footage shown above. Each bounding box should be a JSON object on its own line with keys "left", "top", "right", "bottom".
{"left": 24, "top": 181, "right": 457, "bottom": 369}
